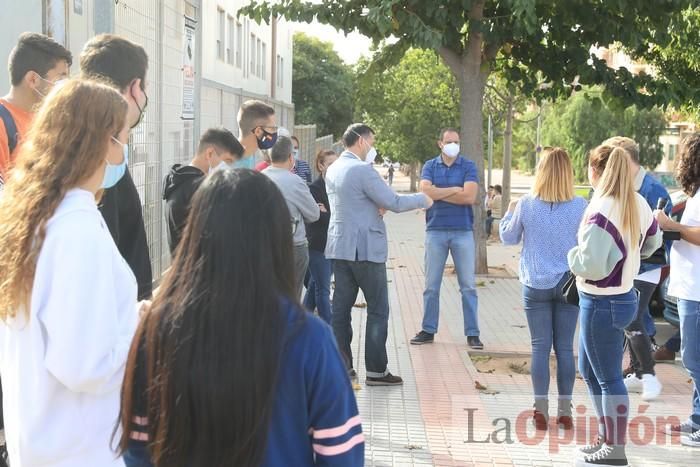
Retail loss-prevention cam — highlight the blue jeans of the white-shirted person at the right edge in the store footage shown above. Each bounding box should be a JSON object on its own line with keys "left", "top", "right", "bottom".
{"left": 678, "top": 299, "right": 700, "bottom": 428}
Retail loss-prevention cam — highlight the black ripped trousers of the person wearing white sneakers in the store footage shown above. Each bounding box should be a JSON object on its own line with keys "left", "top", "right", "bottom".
{"left": 625, "top": 281, "right": 656, "bottom": 376}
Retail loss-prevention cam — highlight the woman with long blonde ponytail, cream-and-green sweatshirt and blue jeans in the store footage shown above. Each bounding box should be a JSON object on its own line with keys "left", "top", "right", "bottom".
{"left": 568, "top": 145, "right": 662, "bottom": 466}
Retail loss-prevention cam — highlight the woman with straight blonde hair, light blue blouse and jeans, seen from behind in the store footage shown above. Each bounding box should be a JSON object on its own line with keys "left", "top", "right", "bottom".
{"left": 500, "top": 148, "right": 586, "bottom": 430}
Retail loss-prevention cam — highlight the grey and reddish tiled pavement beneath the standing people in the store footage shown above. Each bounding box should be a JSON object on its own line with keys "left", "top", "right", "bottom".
{"left": 353, "top": 213, "right": 700, "bottom": 467}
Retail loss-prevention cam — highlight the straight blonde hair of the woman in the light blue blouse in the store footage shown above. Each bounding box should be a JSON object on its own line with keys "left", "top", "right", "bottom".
{"left": 532, "top": 148, "right": 575, "bottom": 203}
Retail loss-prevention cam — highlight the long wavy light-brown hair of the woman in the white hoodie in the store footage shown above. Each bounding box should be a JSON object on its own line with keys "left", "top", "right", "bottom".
{"left": 0, "top": 80, "right": 127, "bottom": 321}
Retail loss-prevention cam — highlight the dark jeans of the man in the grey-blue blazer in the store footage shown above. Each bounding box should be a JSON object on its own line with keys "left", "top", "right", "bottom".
{"left": 331, "top": 260, "right": 389, "bottom": 378}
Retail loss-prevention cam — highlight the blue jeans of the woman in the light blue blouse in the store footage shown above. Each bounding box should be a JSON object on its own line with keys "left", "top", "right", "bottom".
{"left": 523, "top": 274, "right": 578, "bottom": 400}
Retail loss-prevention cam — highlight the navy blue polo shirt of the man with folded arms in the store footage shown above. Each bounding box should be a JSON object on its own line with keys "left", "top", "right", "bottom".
{"left": 421, "top": 156, "right": 479, "bottom": 231}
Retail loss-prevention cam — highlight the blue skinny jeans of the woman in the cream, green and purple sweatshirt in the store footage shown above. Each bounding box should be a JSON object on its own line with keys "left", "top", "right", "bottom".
{"left": 578, "top": 289, "right": 639, "bottom": 445}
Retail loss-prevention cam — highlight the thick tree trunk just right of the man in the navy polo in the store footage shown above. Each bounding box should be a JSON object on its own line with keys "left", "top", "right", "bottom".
{"left": 458, "top": 67, "right": 488, "bottom": 274}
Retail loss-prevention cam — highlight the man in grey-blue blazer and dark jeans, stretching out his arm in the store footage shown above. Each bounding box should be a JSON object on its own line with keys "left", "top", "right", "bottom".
{"left": 326, "top": 123, "right": 433, "bottom": 386}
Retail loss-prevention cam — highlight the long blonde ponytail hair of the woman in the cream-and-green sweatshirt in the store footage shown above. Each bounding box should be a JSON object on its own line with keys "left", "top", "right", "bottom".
{"left": 589, "top": 145, "right": 641, "bottom": 247}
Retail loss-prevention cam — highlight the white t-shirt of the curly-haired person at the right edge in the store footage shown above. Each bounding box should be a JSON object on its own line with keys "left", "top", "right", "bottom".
{"left": 668, "top": 191, "right": 700, "bottom": 302}
